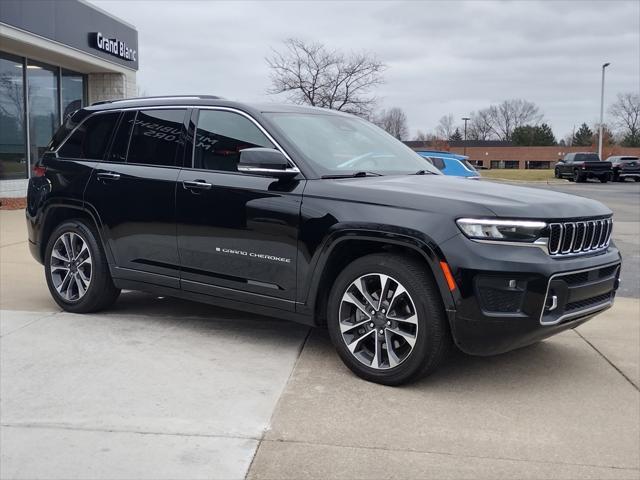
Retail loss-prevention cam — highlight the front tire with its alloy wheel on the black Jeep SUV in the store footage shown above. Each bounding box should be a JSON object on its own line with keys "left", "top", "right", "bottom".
{"left": 327, "top": 254, "right": 451, "bottom": 385}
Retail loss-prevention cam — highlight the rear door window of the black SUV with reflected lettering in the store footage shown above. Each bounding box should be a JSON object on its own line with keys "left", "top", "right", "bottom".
{"left": 127, "top": 109, "right": 186, "bottom": 166}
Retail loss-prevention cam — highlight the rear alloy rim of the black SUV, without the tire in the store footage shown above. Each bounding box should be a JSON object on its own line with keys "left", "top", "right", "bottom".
{"left": 49, "top": 232, "right": 93, "bottom": 302}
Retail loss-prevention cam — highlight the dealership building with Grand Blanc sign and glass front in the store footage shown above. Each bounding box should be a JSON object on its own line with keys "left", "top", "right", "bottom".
{"left": 0, "top": 0, "right": 139, "bottom": 197}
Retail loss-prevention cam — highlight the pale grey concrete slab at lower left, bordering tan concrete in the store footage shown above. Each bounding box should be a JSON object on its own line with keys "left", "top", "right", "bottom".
{"left": 0, "top": 306, "right": 308, "bottom": 478}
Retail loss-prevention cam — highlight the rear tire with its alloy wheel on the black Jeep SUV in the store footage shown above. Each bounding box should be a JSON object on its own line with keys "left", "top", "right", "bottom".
{"left": 44, "top": 219, "right": 120, "bottom": 313}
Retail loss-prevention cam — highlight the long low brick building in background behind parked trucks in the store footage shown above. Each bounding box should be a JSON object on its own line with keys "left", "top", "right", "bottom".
{"left": 416, "top": 146, "right": 640, "bottom": 168}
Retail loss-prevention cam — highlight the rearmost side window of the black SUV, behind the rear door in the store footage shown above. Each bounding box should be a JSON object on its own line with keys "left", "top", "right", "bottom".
{"left": 58, "top": 112, "right": 120, "bottom": 160}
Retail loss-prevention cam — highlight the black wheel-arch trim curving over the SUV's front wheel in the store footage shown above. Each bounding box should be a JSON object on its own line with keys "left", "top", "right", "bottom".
{"left": 297, "top": 224, "right": 455, "bottom": 315}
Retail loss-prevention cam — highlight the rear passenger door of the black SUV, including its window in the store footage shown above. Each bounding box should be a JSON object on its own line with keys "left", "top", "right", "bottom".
{"left": 85, "top": 107, "right": 188, "bottom": 288}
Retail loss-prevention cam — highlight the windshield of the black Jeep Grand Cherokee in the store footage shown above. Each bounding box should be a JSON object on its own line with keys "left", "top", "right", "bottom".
{"left": 265, "top": 113, "right": 440, "bottom": 175}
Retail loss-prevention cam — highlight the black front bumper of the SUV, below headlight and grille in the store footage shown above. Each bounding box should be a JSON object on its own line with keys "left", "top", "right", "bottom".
{"left": 442, "top": 235, "right": 621, "bottom": 355}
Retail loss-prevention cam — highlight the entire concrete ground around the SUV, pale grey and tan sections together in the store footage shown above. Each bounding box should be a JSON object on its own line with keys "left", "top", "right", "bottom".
{"left": 0, "top": 211, "right": 640, "bottom": 479}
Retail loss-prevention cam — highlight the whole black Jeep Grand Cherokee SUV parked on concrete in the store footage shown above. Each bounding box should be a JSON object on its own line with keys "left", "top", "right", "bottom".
{"left": 26, "top": 97, "right": 621, "bottom": 385}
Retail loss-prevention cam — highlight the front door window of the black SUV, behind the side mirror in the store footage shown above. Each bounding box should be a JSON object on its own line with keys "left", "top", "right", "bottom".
{"left": 193, "top": 110, "right": 275, "bottom": 172}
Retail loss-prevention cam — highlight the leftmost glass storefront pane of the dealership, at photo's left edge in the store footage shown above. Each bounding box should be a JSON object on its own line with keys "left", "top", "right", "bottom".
{"left": 0, "top": 53, "right": 28, "bottom": 180}
